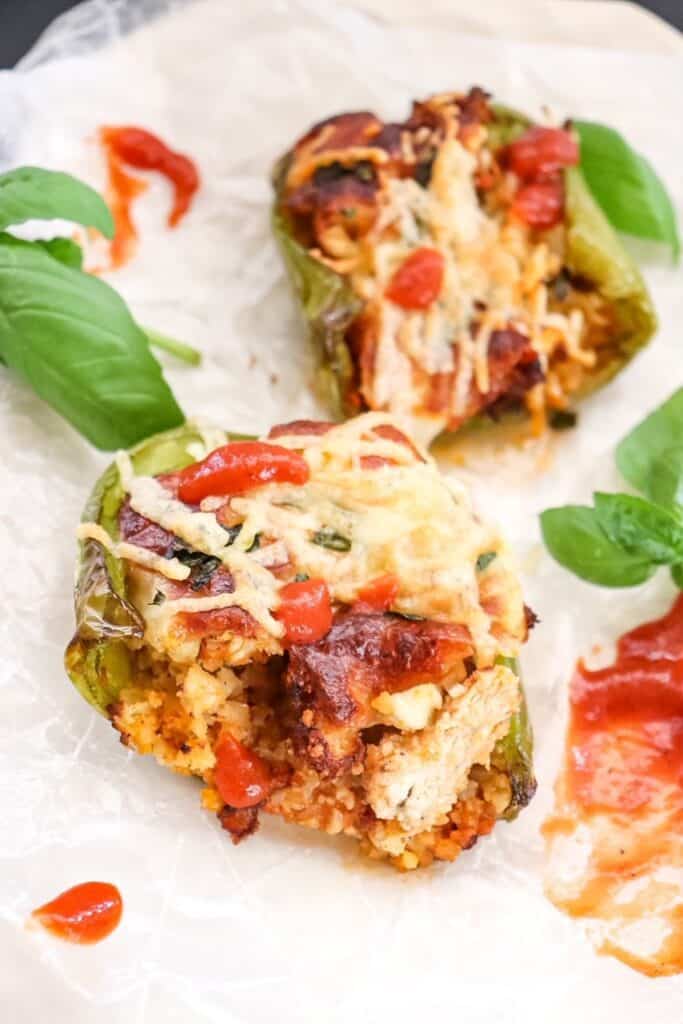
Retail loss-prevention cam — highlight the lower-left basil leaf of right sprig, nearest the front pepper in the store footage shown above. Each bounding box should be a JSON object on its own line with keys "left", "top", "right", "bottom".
{"left": 541, "top": 505, "right": 655, "bottom": 587}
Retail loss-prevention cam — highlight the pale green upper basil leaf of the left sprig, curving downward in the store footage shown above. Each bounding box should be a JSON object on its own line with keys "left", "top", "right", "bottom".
{"left": 0, "top": 167, "right": 114, "bottom": 239}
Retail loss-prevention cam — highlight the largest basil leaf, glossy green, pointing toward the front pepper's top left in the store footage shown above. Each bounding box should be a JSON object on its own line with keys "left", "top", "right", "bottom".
{"left": 0, "top": 243, "right": 183, "bottom": 450}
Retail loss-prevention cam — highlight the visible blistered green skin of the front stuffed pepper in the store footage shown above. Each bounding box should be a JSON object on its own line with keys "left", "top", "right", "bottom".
{"left": 65, "top": 424, "right": 536, "bottom": 820}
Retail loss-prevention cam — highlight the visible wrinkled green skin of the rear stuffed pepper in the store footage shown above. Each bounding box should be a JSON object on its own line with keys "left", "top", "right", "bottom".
{"left": 271, "top": 103, "right": 657, "bottom": 434}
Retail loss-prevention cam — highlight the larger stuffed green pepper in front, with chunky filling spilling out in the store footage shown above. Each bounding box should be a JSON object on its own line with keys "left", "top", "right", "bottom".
{"left": 67, "top": 413, "right": 536, "bottom": 869}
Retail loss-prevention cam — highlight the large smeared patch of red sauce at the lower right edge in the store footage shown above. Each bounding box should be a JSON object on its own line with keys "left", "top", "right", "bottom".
{"left": 543, "top": 595, "right": 683, "bottom": 977}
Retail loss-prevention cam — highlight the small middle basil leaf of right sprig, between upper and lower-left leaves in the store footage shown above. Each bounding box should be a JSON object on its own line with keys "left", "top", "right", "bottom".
{"left": 593, "top": 493, "right": 683, "bottom": 565}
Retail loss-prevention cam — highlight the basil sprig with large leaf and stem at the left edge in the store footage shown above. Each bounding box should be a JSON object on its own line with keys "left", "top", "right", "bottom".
{"left": 0, "top": 167, "right": 198, "bottom": 450}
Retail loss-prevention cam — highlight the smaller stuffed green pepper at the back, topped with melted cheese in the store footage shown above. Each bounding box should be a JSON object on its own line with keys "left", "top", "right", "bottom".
{"left": 273, "top": 88, "right": 656, "bottom": 443}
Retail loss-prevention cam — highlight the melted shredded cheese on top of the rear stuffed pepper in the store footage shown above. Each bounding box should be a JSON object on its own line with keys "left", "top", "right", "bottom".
{"left": 336, "top": 128, "right": 595, "bottom": 442}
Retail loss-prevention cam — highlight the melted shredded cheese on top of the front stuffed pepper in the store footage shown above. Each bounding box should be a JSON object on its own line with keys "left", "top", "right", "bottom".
{"left": 104, "top": 413, "right": 524, "bottom": 666}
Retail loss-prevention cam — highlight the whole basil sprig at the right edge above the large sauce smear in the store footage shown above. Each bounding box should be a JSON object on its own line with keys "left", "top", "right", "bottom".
{"left": 541, "top": 388, "right": 683, "bottom": 589}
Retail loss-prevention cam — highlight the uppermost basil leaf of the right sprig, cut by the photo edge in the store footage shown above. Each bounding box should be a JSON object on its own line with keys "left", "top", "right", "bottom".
{"left": 616, "top": 388, "right": 683, "bottom": 500}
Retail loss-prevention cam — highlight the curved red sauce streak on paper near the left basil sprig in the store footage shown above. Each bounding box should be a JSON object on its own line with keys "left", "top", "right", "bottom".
{"left": 99, "top": 125, "right": 200, "bottom": 268}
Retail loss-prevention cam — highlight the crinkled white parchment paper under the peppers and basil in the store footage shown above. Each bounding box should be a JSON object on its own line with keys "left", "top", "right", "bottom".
{"left": 0, "top": 0, "right": 683, "bottom": 1024}
